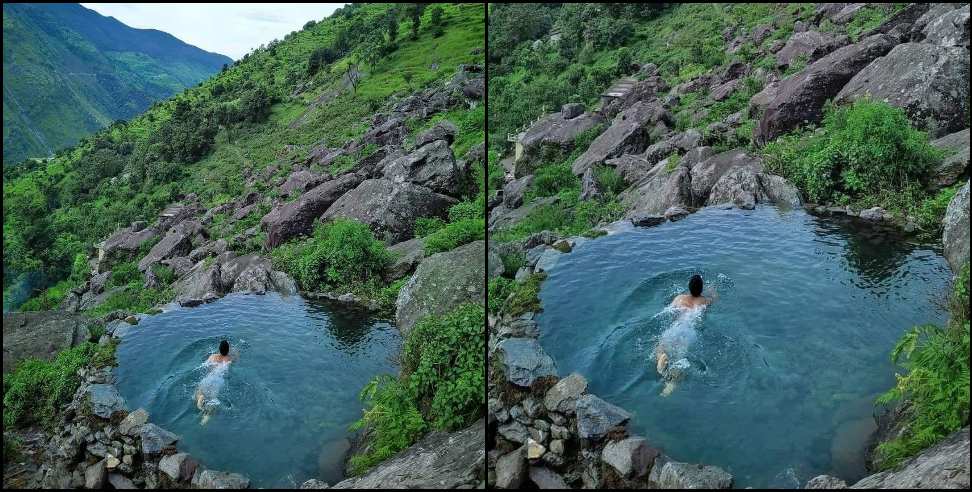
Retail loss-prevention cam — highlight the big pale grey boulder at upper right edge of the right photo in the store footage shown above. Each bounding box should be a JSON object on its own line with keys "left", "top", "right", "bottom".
{"left": 836, "top": 43, "right": 969, "bottom": 137}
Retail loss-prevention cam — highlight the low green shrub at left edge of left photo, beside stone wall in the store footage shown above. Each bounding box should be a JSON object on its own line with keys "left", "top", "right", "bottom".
{"left": 3, "top": 342, "right": 97, "bottom": 429}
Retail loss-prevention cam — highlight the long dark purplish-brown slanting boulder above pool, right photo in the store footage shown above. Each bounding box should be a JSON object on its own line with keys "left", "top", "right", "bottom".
{"left": 754, "top": 34, "right": 894, "bottom": 144}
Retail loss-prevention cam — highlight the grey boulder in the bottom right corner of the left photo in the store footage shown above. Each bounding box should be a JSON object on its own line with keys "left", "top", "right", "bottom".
{"left": 332, "top": 419, "right": 486, "bottom": 490}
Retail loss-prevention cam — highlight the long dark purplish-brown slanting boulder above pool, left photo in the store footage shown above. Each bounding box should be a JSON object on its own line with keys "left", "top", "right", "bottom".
{"left": 261, "top": 173, "right": 361, "bottom": 248}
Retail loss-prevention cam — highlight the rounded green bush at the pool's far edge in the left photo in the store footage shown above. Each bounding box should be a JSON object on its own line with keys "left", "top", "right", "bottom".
{"left": 271, "top": 219, "right": 391, "bottom": 291}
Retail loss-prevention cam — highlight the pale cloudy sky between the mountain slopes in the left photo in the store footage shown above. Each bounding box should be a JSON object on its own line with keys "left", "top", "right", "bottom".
{"left": 81, "top": 3, "right": 345, "bottom": 60}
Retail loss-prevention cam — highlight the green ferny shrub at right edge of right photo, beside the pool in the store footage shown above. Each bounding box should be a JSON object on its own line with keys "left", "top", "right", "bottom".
{"left": 877, "top": 263, "right": 970, "bottom": 469}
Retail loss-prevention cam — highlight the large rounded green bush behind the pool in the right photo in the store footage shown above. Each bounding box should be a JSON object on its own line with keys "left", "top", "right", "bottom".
{"left": 764, "top": 100, "right": 942, "bottom": 202}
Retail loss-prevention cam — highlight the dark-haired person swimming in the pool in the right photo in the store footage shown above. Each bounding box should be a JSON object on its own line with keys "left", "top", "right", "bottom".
{"left": 655, "top": 275, "right": 717, "bottom": 396}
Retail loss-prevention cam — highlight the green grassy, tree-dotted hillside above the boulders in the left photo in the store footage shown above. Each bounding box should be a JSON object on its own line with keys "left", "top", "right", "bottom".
{"left": 3, "top": 4, "right": 485, "bottom": 308}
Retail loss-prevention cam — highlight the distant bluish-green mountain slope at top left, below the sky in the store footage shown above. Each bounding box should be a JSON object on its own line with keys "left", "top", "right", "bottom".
{"left": 3, "top": 4, "right": 232, "bottom": 164}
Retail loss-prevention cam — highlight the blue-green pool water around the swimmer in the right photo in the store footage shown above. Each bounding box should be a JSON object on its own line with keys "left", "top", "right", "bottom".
{"left": 539, "top": 207, "right": 950, "bottom": 487}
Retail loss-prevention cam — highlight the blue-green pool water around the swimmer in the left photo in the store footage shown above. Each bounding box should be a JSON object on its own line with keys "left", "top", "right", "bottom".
{"left": 116, "top": 294, "right": 400, "bottom": 487}
